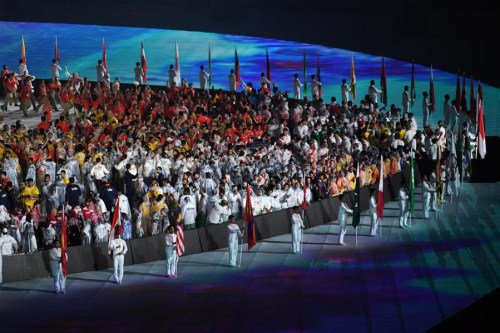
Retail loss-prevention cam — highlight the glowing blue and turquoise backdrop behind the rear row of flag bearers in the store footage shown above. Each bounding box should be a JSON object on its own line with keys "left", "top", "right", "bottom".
{"left": 0, "top": 22, "right": 500, "bottom": 136}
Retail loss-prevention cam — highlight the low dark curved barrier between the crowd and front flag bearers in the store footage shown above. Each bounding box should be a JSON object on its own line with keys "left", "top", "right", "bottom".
{"left": 2, "top": 161, "right": 422, "bottom": 283}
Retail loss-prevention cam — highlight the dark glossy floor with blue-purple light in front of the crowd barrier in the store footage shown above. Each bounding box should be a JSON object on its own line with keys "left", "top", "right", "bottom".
{"left": 0, "top": 183, "right": 500, "bottom": 333}
